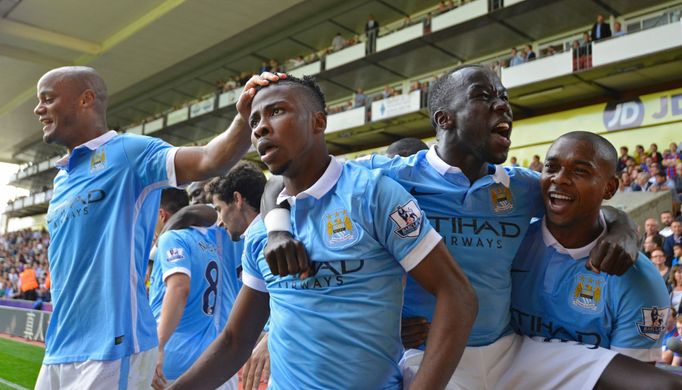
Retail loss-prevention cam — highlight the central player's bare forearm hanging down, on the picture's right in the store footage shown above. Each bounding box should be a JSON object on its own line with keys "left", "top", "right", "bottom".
{"left": 410, "top": 281, "right": 478, "bottom": 389}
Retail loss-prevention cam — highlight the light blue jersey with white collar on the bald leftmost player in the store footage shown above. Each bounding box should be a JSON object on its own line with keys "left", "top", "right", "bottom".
{"left": 43, "top": 131, "right": 177, "bottom": 364}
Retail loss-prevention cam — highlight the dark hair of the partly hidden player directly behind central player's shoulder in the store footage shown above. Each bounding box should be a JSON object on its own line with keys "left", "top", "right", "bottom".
{"left": 208, "top": 161, "right": 266, "bottom": 212}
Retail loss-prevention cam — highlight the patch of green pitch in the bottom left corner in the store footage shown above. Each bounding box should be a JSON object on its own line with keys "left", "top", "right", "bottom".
{"left": 0, "top": 338, "right": 45, "bottom": 390}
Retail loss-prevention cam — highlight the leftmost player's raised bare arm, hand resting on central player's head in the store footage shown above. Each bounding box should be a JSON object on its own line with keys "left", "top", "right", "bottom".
{"left": 175, "top": 72, "right": 286, "bottom": 184}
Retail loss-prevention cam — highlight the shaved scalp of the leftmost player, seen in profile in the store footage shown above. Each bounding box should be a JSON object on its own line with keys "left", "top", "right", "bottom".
{"left": 38, "top": 66, "right": 108, "bottom": 112}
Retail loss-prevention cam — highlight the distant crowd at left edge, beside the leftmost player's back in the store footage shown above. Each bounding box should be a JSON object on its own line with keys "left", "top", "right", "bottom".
{"left": 0, "top": 229, "right": 50, "bottom": 302}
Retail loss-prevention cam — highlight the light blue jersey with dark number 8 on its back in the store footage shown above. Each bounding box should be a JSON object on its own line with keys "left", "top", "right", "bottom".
{"left": 149, "top": 228, "right": 222, "bottom": 379}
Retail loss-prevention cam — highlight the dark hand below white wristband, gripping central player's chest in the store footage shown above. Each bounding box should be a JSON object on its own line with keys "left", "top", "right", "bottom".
{"left": 263, "top": 231, "right": 313, "bottom": 279}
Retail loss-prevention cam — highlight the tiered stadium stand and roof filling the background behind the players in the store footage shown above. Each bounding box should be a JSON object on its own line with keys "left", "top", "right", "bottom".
{"left": 0, "top": 0, "right": 682, "bottom": 380}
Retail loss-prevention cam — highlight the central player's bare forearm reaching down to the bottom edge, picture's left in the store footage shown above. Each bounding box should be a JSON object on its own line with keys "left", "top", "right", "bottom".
{"left": 170, "top": 329, "right": 258, "bottom": 389}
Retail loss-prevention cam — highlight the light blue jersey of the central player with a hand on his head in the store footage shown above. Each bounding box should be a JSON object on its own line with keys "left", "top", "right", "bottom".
{"left": 242, "top": 158, "right": 441, "bottom": 389}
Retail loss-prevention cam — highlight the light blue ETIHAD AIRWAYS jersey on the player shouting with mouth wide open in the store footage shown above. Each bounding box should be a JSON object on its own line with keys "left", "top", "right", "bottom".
{"left": 357, "top": 146, "right": 544, "bottom": 348}
